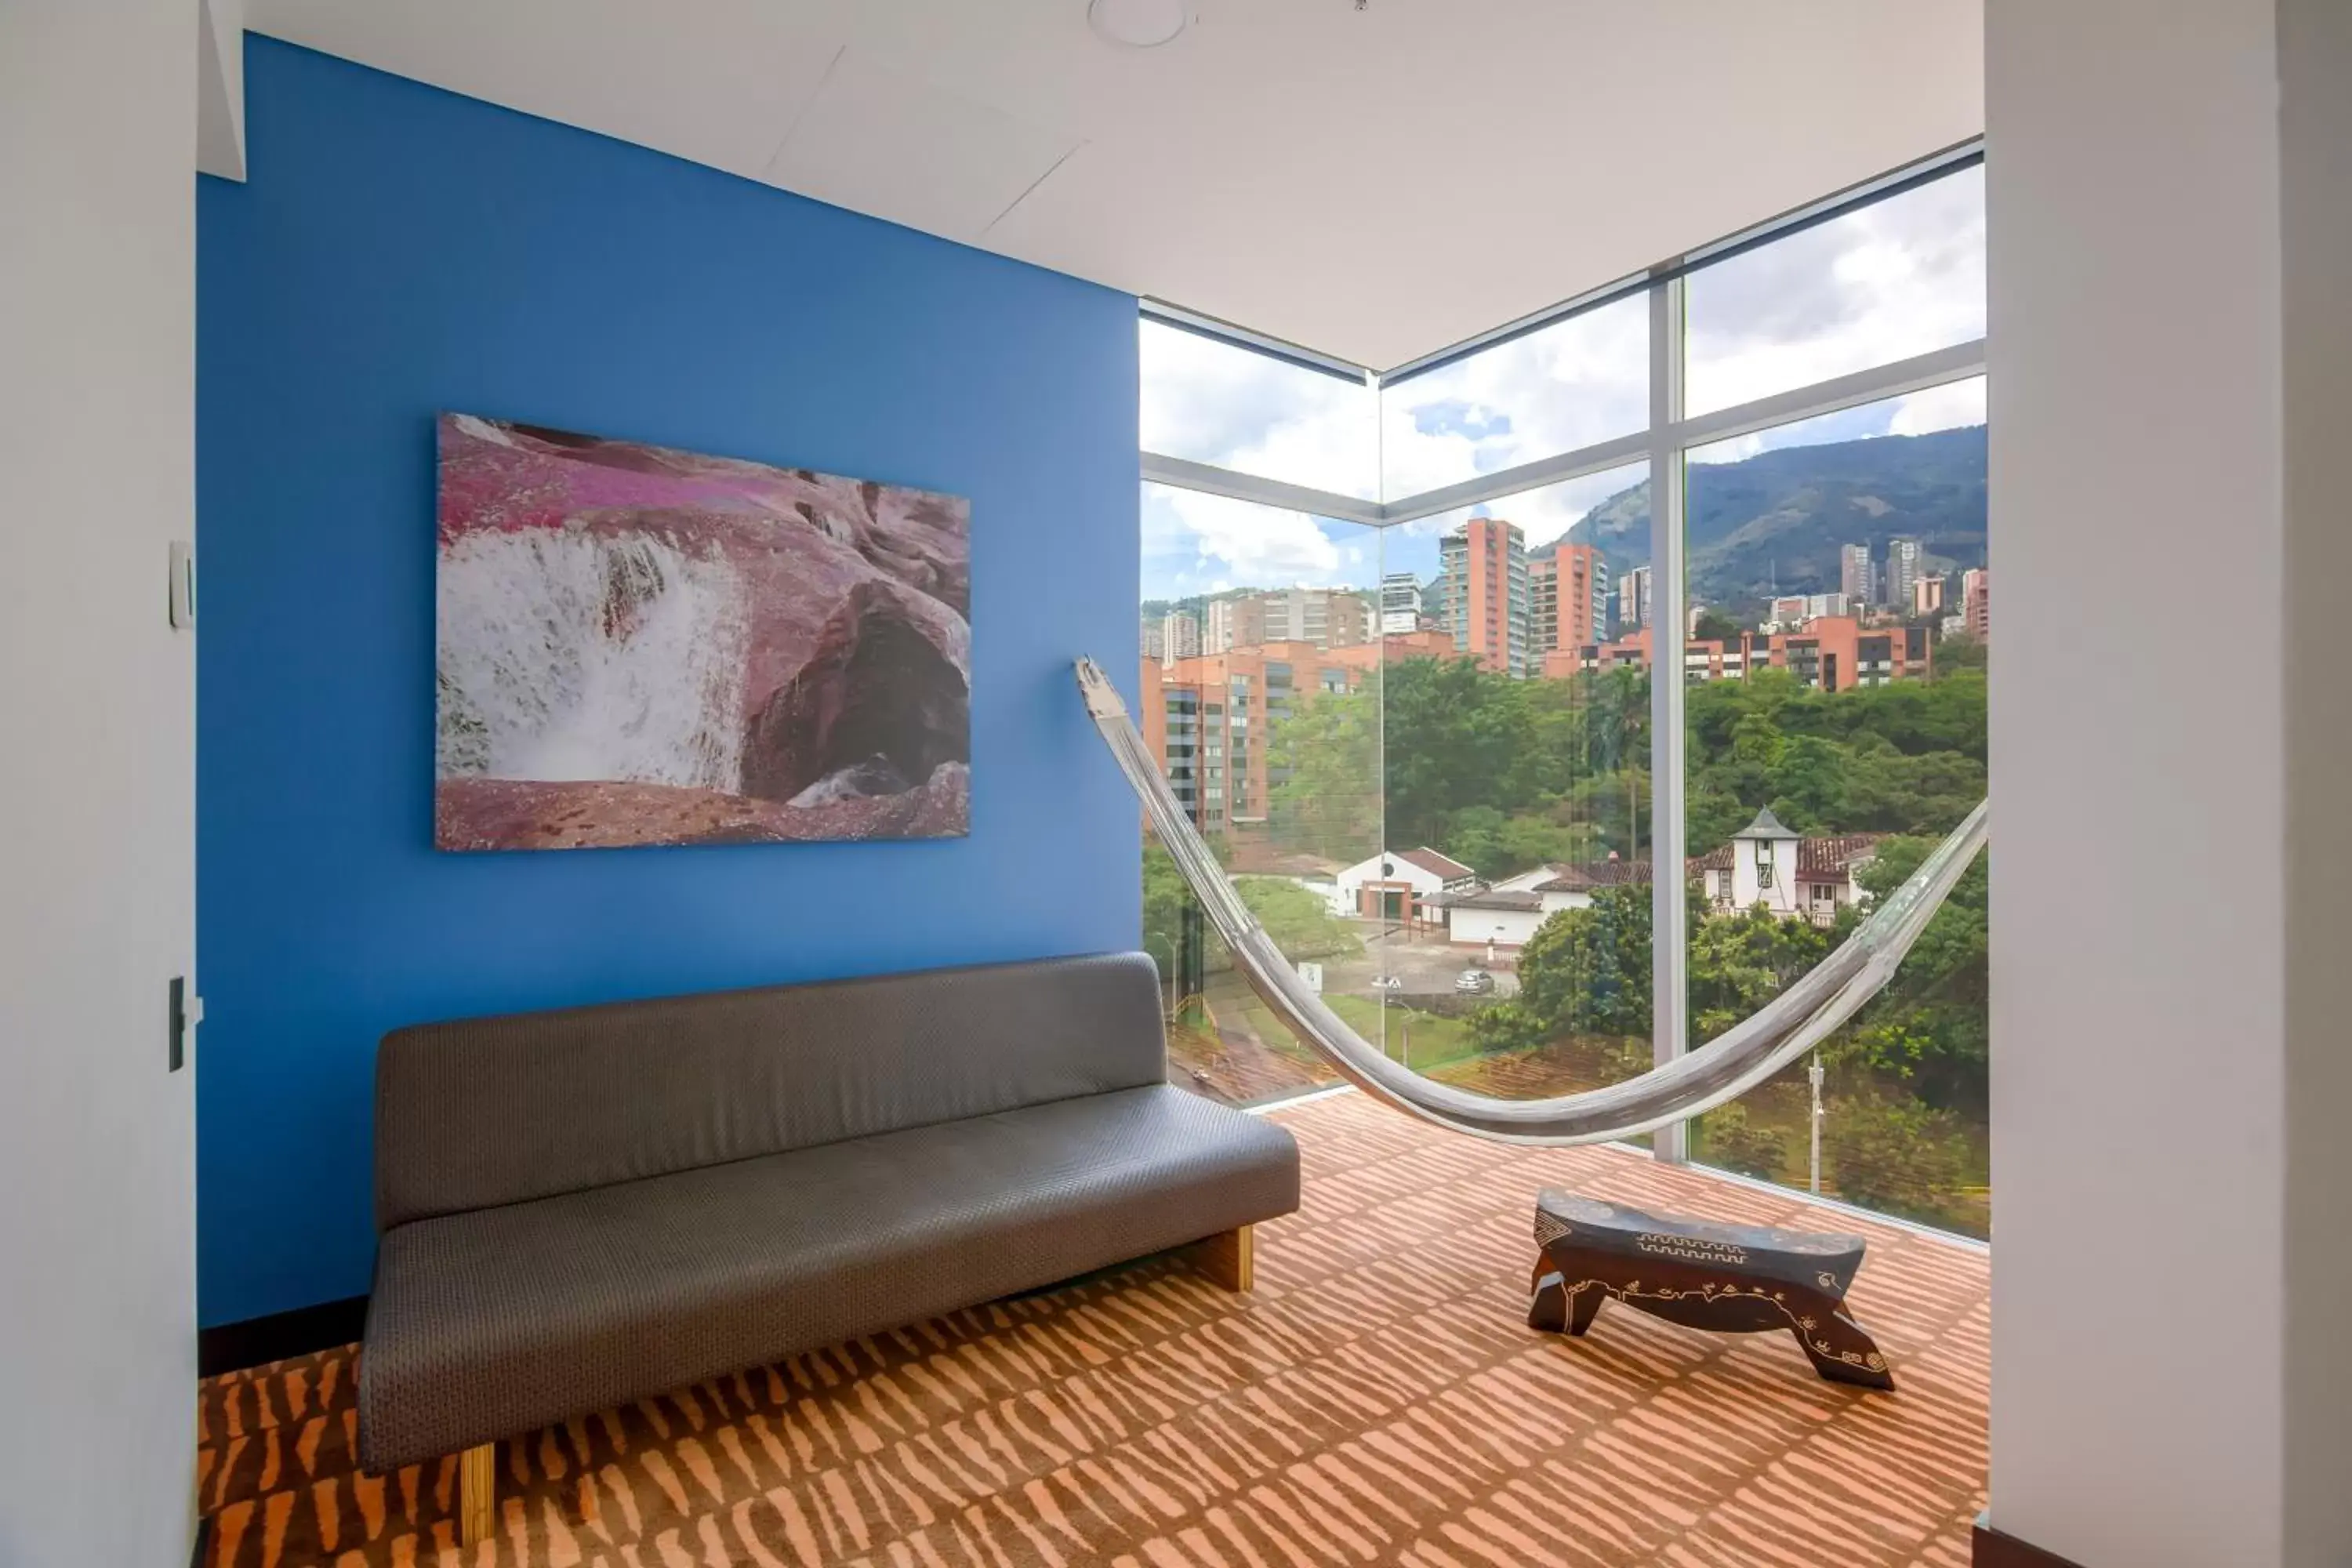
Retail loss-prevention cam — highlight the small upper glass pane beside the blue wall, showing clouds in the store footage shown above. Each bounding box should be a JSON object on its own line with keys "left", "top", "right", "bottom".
{"left": 1136, "top": 320, "right": 1381, "bottom": 501}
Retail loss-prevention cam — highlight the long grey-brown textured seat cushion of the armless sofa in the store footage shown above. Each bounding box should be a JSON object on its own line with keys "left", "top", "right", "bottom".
{"left": 360, "top": 1083, "right": 1298, "bottom": 1474}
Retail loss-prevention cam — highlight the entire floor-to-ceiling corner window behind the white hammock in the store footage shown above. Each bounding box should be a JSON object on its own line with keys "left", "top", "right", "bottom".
{"left": 1141, "top": 148, "right": 1990, "bottom": 1232}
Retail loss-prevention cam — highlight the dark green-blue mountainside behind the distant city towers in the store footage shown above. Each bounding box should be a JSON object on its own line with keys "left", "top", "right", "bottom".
{"left": 1566, "top": 426, "right": 1985, "bottom": 612}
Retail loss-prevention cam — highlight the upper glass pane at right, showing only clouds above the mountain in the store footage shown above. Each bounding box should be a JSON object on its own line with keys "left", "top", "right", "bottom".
{"left": 1684, "top": 165, "right": 1985, "bottom": 414}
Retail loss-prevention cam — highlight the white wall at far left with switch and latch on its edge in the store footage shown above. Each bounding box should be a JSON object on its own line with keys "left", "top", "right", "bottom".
{"left": 0, "top": 0, "right": 198, "bottom": 1568}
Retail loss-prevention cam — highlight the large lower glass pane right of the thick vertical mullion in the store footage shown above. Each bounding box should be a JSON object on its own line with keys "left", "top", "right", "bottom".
{"left": 1684, "top": 379, "right": 1990, "bottom": 1236}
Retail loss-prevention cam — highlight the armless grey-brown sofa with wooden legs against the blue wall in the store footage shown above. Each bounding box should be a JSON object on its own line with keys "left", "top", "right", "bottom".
{"left": 360, "top": 954, "right": 1298, "bottom": 1540}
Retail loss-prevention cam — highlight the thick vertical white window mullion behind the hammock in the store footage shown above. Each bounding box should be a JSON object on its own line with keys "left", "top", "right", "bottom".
{"left": 1649, "top": 278, "right": 1689, "bottom": 1163}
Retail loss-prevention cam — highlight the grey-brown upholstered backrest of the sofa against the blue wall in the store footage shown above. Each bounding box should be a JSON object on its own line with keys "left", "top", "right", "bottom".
{"left": 376, "top": 952, "right": 1167, "bottom": 1232}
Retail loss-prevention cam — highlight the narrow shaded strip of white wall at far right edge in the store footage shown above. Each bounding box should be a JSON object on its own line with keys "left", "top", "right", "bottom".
{"left": 2279, "top": 0, "right": 2352, "bottom": 1563}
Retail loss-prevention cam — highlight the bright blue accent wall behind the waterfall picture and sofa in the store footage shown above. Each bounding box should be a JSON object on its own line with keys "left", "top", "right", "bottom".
{"left": 200, "top": 38, "right": 1141, "bottom": 1326}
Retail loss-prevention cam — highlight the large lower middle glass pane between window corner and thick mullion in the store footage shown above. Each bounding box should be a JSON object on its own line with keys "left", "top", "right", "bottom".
{"left": 1381, "top": 466, "right": 1651, "bottom": 1098}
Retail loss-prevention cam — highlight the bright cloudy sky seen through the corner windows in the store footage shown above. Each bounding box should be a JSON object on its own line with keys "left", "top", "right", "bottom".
{"left": 1141, "top": 169, "right": 1985, "bottom": 600}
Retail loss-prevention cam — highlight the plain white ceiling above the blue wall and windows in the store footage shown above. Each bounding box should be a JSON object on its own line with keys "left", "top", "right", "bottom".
{"left": 245, "top": 0, "right": 1983, "bottom": 367}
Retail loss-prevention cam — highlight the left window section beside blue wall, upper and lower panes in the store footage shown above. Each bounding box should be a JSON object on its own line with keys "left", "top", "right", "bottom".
{"left": 1138, "top": 320, "right": 1383, "bottom": 1105}
